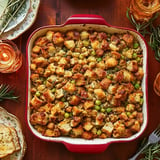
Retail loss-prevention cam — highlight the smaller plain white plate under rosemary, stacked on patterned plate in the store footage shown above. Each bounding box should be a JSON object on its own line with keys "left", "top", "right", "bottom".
{"left": 0, "top": 0, "right": 30, "bottom": 32}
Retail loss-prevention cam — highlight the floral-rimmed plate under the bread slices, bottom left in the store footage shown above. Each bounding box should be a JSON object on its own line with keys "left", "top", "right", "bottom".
{"left": 0, "top": 107, "right": 26, "bottom": 160}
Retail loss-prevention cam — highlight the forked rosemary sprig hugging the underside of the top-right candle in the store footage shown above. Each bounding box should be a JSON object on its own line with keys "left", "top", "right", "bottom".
{"left": 126, "top": 8, "right": 159, "bottom": 36}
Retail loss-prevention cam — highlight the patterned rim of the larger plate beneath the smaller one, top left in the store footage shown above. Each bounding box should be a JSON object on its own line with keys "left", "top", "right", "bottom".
{"left": 0, "top": 0, "right": 40, "bottom": 40}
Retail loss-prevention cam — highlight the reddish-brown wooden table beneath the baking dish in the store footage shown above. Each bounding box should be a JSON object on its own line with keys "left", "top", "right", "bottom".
{"left": 0, "top": 0, "right": 160, "bottom": 160}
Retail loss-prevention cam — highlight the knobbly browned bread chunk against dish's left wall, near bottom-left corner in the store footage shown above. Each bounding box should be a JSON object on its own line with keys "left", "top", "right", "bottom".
{"left": 30, "top": 112, "right": 49, "bottom": 125}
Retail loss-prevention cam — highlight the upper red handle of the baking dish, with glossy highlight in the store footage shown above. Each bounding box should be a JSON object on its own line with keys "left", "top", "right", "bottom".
{"left": 64, "top": 14, "right": 110, "bottom": 26}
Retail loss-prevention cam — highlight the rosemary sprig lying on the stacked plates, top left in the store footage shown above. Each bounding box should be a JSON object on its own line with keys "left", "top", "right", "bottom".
{"left": 0, "top": 0, "right": 26, "bottom": 35}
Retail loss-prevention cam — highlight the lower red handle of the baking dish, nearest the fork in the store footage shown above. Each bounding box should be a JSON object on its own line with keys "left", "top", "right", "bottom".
{"left": 64, "top": 142, "right": 109, "bottom": 153}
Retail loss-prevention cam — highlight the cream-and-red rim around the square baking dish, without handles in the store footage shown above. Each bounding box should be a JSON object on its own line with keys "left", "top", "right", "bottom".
{"left": 26, "top": 17, "right": 148, "bottom": 151}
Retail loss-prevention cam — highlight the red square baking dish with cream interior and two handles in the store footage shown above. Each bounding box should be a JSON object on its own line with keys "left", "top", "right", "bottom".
{"left": 26, "top": 15, "right": 148, "bottom": 153}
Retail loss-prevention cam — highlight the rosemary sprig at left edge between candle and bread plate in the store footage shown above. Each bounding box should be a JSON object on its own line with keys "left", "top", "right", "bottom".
{"left": 0, "top": 84, "right": 19, "bottom": 101}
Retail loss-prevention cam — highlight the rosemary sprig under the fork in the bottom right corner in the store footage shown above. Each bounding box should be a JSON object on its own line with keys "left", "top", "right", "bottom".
{"left": 140, "top": 142, "right": 160, "bottom": 160}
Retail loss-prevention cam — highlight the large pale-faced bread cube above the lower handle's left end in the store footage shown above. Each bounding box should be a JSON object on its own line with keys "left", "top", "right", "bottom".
{"left": 58, "top": 119, "right": 72, "bottom": 135}
